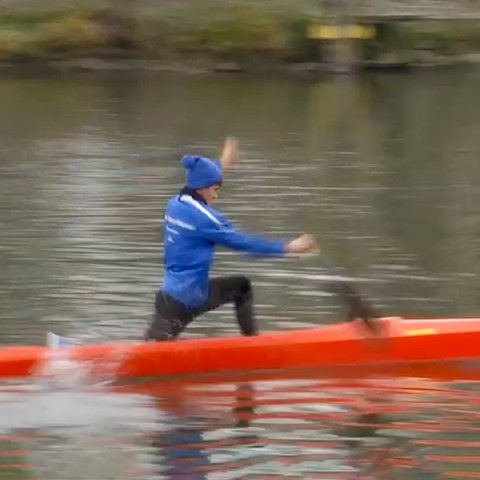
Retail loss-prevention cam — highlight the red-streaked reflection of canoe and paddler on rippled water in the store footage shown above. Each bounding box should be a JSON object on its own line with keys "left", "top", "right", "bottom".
{"left": 114, "top": 377, "right": 480, "bottom": 480}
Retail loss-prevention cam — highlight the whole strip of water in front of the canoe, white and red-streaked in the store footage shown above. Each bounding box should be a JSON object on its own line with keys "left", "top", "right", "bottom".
{"left": 0, "top": 366, "right": 480, "bottom": 480}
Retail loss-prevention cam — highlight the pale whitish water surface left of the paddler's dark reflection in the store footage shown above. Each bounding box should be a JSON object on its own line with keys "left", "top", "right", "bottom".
{"left": 0, "top": 387, "right": 158, "bottom": 480}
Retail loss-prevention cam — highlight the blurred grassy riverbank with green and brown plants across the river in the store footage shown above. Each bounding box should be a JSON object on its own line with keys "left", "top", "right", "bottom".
{"left": 0, "top": 0, "right": 480, "bottom": 70}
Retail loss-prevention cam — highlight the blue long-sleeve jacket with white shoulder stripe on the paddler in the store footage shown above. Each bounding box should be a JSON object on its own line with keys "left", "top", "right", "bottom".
{"left": 161, "top": 193, "right": 285, "bottom": 307}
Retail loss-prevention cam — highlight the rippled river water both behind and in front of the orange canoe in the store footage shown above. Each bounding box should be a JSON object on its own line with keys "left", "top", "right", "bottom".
{"left": 0, "top": 72, "right": 480, "bottom": 480}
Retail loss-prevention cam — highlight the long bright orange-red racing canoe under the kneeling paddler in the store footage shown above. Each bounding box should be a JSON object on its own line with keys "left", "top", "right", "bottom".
{"left": 0, "top": 317, "right": 480, "bottom": 378}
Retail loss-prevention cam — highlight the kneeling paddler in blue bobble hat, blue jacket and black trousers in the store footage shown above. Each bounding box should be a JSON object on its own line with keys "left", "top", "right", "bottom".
{"left": 145, "top": 138, "right": 315, "bottom": 340}
